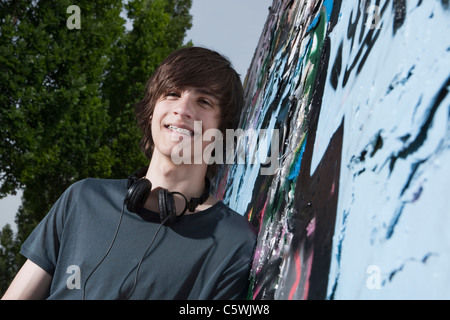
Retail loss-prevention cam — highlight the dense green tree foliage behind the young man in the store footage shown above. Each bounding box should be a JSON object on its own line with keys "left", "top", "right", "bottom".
{"left": 0, "top": 0, "right": 192, "bottom": 289}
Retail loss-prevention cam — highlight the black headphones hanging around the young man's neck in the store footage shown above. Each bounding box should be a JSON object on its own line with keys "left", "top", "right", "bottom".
{"left": 124, "top": 167, "right": 211, "bottom": 226}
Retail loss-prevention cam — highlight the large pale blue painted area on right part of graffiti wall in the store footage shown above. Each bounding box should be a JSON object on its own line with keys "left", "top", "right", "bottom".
{"left": 311, "top": 1, "right": 450, "bottom": 299}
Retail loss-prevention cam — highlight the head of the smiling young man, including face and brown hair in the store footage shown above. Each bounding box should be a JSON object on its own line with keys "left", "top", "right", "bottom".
{"left": 135, "top": 47, "right": 244, "bottom": 178}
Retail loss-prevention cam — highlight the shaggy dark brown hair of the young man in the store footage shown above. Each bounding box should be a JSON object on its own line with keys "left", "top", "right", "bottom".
{"left": 136, "top": 47, "right": 243, "bottom": 176}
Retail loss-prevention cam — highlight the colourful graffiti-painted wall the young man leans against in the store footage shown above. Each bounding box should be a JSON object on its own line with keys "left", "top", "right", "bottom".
{"left": 217, "top": 0, "right": 450, "bottom": 299}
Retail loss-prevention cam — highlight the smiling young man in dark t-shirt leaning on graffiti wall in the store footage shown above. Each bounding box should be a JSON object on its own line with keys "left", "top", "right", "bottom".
{"left": 3, "top": 47, "right": 255, "bottom": 299}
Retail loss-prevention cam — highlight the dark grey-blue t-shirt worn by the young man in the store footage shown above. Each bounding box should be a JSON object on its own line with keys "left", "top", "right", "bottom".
{"left": 21, "top": 179, "right": 256, "bottom": 300}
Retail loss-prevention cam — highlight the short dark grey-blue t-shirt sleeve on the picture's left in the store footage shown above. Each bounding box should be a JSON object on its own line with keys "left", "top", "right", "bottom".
{"left": 20, "top": 183, "right": 79, "bottom": 276}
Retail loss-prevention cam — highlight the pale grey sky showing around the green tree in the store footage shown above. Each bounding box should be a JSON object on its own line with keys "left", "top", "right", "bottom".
{"left": 0, "top": 0, "right": 272, "bottom": 231}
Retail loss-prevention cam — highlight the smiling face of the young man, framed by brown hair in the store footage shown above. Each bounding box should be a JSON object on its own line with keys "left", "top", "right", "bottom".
{"left": 151, "top": 88, "right": 220, "bottom": 163}
